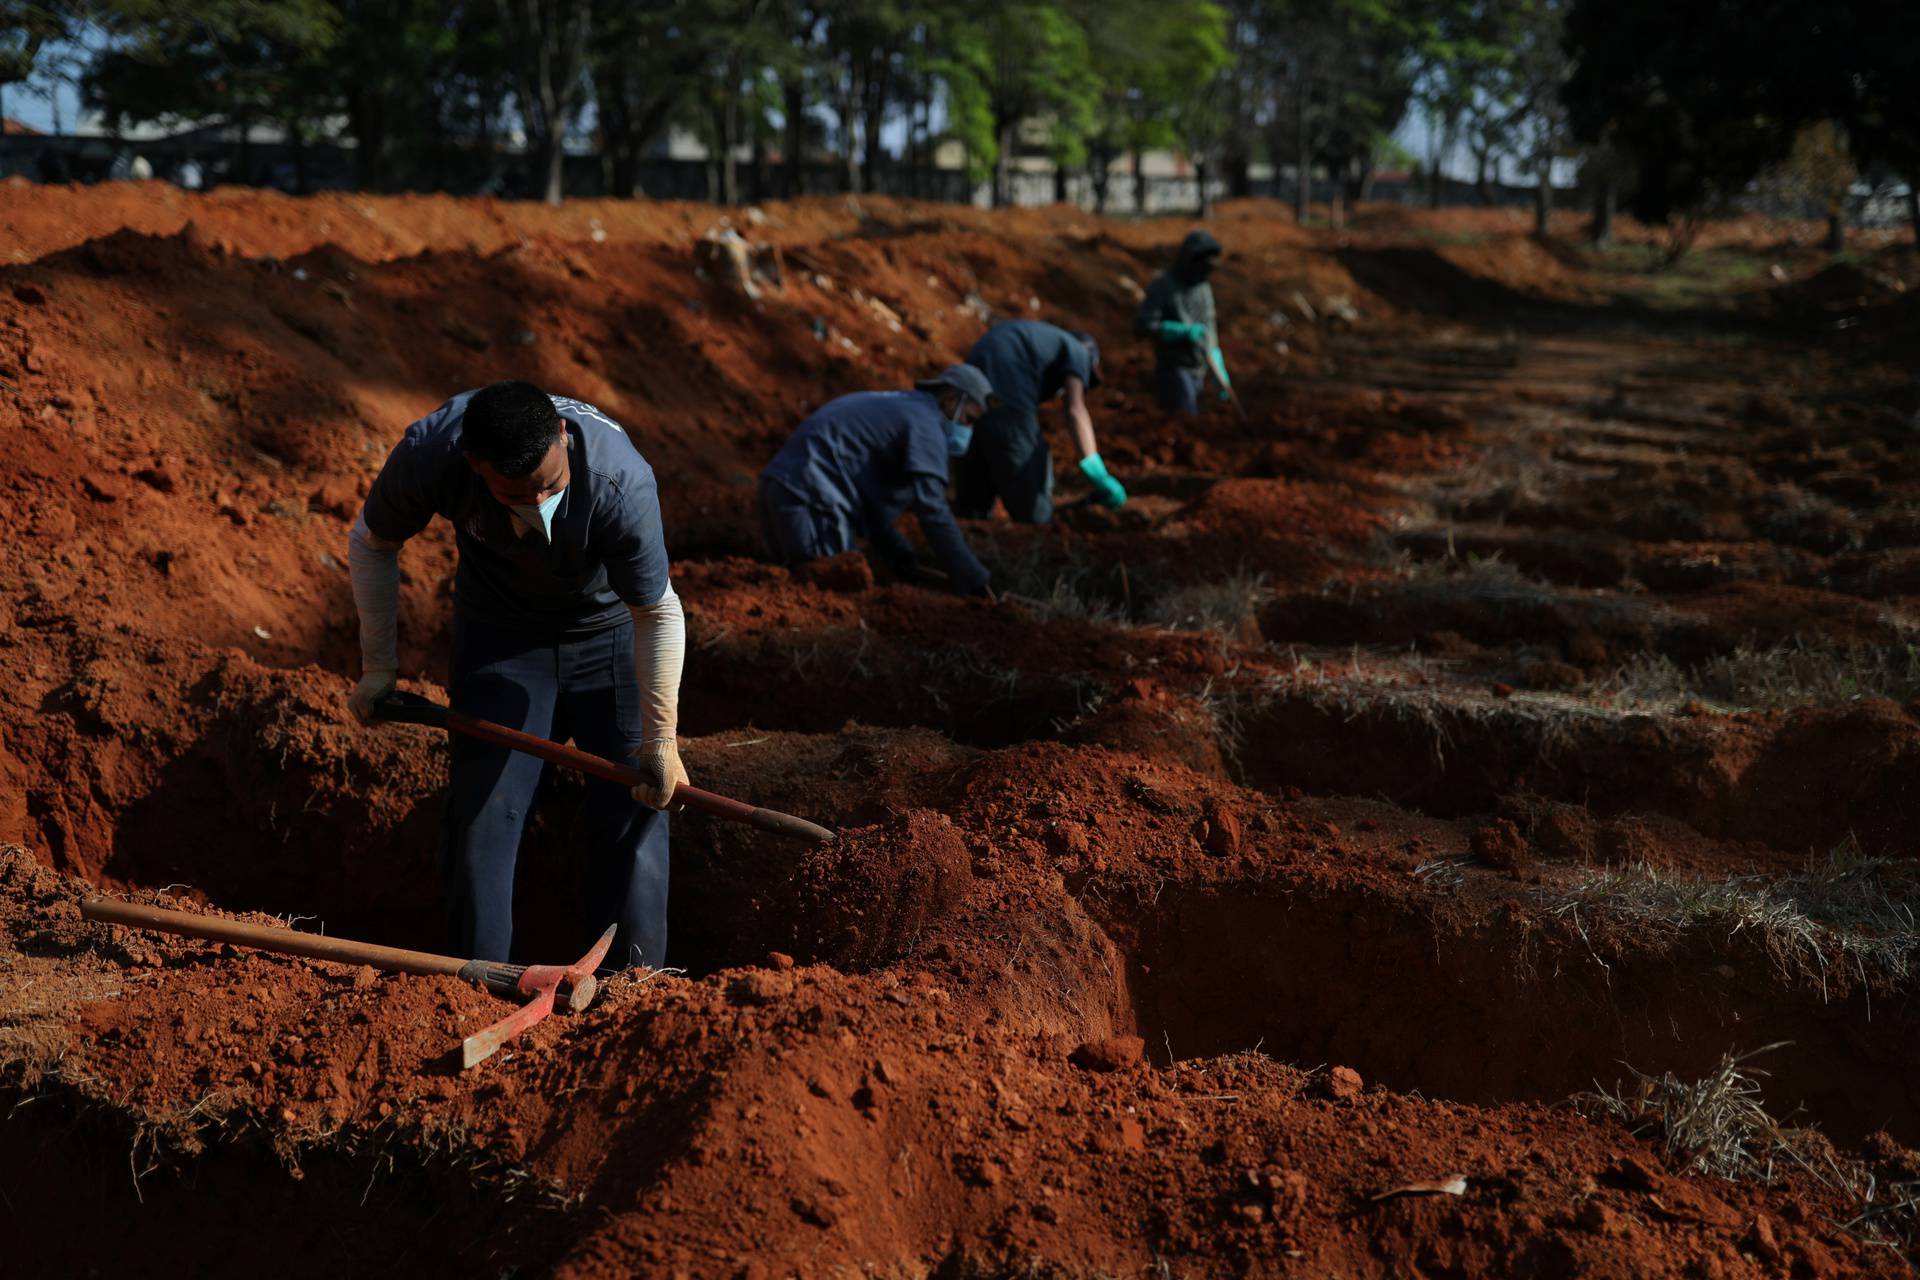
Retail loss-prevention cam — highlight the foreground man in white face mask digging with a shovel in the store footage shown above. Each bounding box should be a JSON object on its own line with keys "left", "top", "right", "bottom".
{"left": 348, "top": 382, "right": 687, "bottom": 967}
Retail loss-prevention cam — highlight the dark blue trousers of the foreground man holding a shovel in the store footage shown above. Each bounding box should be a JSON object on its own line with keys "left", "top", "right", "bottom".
{"left": 440, "top": 616, "right": 666, "bottom": 967}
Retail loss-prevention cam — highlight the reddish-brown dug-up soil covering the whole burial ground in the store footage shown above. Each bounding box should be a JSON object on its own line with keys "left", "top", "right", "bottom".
{"left": 0, "top": 184, "right": 1920, "bottom": 1276}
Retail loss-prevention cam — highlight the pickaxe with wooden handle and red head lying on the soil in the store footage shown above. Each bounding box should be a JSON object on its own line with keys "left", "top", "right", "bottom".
{"left": 81, "top": 898, "right": 614, "bottom": 1071}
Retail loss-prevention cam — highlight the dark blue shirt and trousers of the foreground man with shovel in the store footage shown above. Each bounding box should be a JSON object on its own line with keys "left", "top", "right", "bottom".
{"left": 363, "top": 391, "right": 668, "bottom": 967}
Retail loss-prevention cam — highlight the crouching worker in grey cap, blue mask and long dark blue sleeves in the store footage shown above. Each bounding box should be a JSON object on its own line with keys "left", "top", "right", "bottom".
{"left": 760, "top": 365, "right": 993, "bottom": 595}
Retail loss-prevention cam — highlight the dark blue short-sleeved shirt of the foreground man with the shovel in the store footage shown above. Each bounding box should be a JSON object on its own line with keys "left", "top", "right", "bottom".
{"left": 365, "top": 391, "right": 668, "bottom": 635}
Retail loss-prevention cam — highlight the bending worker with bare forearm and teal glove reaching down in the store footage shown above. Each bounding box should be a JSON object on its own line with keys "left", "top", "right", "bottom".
{"left": 954, "top": 320, "right": 1127, "bottom": 524}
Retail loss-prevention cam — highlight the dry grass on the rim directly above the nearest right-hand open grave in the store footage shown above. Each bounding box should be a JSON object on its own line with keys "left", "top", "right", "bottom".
{"left": 1549, "top": 839, "right": 1920, "bottom": 998}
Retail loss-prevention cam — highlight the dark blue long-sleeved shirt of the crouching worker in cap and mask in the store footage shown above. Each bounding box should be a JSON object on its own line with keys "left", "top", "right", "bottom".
{"left": 760, "top": 391, "right": 987, "bottom": 589}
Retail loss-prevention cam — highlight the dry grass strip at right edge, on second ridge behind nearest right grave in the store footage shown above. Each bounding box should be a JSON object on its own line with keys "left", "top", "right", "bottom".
{"left": 1590, "top": 643, "right": 1920, "bottom": 712}
